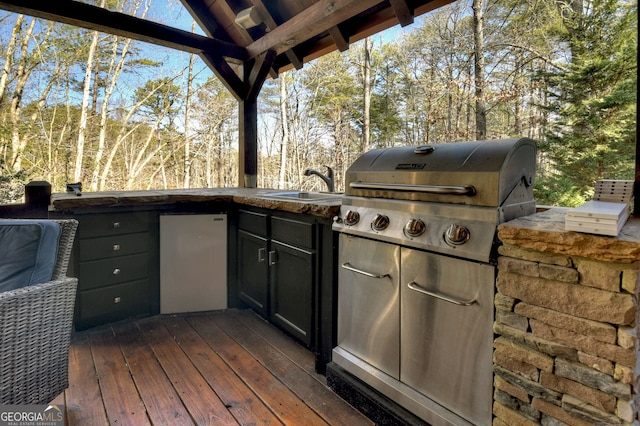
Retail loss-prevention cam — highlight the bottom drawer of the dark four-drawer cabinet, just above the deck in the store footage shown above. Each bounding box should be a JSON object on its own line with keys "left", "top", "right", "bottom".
{"left": 78, "top": 280, "right": 150, "bottom": 328}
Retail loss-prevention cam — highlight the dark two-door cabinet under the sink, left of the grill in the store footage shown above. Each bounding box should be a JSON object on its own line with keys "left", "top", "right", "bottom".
{"left": 238, "top": 209, "right": 330, "bottom": 348}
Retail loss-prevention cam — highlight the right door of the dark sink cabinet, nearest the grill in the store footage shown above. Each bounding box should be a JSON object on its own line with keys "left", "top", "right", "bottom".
{"left": 270, "top": 240, "right": 316, "bottom": 346}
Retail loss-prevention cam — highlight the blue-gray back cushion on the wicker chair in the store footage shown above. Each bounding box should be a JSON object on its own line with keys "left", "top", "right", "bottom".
{"left": 0, "top": 219, "right": 60, "bottom": 291}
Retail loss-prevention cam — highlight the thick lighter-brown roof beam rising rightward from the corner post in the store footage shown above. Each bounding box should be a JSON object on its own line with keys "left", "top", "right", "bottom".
{"left": 247, "top": 0, "right": 380, "bottom": 58}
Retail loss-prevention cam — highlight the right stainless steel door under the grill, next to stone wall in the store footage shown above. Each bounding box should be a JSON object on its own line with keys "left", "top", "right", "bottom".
{"left": 400, "top": 247, "right": 495, "bottom": 425}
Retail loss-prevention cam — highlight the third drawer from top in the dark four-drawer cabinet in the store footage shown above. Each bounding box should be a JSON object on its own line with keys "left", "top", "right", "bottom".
{"left": 78, "top": 253, "right": 149, "bottom": 290}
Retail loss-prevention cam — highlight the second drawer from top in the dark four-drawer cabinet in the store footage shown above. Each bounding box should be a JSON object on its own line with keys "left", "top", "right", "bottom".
{"left": 78, "top": 232, "right": 149, "bottom": 262}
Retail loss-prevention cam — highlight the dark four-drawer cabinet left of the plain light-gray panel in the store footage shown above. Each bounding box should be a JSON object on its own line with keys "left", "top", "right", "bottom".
{"left": 72, "top": 211, "right": 159, "bottom": 330}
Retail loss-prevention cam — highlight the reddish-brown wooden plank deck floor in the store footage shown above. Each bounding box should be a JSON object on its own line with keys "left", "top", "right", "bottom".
{"left": 54, "top": 310, "right": 372, "bottom": 426}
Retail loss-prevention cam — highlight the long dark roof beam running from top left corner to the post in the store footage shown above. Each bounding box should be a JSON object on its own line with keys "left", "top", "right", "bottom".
{"left": 0, "top": 0, "right": 247, "bottom": 61}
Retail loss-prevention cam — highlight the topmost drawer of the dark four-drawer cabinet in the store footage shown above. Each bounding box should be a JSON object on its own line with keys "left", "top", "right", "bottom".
{"left": 78, "top": 212, "right": 149, "bottom": 239}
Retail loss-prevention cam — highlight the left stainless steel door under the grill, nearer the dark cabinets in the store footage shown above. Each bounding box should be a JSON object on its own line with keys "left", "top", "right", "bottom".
{"left": 338, "top": 234, "right": 400, "bottom": 379}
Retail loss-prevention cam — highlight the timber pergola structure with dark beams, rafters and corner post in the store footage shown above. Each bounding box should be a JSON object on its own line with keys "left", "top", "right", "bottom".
{"left": 0, "top": 0, "right": 640, "bottom": 209}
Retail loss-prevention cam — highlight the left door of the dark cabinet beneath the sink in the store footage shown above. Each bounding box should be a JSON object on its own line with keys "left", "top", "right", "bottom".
{"left": 238, "top": 230, "right": 269, "bottom": 318}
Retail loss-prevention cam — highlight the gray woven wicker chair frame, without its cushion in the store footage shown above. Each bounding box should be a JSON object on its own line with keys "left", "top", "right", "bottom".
{"left": 0, "top": 219, "right": 78, "bottom": 405}
